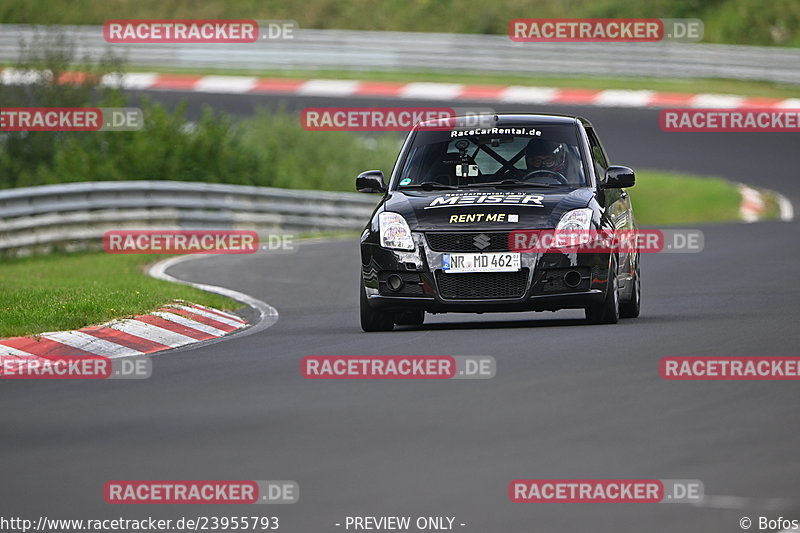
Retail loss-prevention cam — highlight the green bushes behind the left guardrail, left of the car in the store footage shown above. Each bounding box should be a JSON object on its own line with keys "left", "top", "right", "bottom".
{"left": 0, "top": 101, "right": 399, "bottom": 190}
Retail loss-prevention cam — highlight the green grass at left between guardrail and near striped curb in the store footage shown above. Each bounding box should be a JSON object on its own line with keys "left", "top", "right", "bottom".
{"left": 0, "top": 252, "right": 241, "bottom": 337}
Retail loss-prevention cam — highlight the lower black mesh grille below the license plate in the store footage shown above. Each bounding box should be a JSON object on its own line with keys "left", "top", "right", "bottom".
{"left": 436, "top": 268, "right": 528, "bottom": 300}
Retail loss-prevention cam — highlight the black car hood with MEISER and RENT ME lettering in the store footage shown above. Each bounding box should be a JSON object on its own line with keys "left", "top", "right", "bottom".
{"left": 383, "top": 187, "right": 594, "bottom": 231}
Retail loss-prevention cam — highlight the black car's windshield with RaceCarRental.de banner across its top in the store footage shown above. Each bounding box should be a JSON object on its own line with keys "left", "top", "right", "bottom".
{"left": 397, "top": 125, "right": 586, "bottom": 190}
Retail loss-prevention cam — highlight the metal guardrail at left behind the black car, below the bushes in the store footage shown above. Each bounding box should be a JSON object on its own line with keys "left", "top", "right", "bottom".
{"left": 0, "top": 181, "right": 378, "bottom": 255}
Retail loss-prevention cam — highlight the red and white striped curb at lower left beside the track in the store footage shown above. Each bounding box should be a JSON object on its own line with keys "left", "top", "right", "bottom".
{"left": 0, "top": 302, "right": 248, "bottom": 368}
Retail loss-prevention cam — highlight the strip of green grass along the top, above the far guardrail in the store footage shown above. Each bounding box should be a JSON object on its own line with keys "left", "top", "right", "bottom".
{"left": 0, "top": 0, "right": 800, "bottom": 46}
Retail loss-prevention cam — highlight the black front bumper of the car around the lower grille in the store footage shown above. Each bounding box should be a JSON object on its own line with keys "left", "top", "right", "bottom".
{"left": 361, "top": 233, "right": 610, "bottom": 313}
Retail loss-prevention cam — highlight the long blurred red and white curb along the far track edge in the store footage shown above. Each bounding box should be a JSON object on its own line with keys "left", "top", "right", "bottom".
{"left": 0, "top": 68, "right": 800, "bottom": 109}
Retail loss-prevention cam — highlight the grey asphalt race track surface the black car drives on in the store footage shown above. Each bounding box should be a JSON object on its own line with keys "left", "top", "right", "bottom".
{"left": 0, "top": 89, "right": 800, "bottom": 533}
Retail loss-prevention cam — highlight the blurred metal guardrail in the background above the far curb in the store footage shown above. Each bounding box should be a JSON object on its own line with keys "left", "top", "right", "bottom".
{"left": 0, "top": 24, "right": 800, "bottom": 84}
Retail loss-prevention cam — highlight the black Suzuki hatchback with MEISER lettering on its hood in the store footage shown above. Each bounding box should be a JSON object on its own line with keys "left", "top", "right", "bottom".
{"left": 356, "top": 114, "right": 641, "bottom": 331}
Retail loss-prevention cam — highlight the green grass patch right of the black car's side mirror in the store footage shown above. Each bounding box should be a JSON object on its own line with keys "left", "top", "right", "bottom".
{"left": 628, "top": 170, "right": 741, "bottom": 226}
